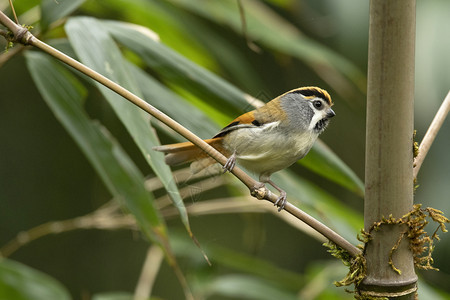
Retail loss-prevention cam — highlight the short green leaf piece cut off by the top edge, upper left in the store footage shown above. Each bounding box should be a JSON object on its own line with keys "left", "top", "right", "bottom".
{"left": 41, "top": 0, "right": 86, "bottom": 31}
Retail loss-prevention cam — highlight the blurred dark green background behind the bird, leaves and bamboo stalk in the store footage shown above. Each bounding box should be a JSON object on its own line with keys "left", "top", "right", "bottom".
{"left": 0, "top": 0, "right": 450, "bottom": 299}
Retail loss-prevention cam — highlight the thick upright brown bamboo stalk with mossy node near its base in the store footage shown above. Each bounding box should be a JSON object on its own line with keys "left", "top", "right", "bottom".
{"left": 360, "top": 0, "right": 417, "bottom": 299}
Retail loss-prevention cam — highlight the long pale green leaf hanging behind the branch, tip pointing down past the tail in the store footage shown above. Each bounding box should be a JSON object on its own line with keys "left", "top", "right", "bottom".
{"left": 66, "top": 17, "right": 192, "bottom": 235}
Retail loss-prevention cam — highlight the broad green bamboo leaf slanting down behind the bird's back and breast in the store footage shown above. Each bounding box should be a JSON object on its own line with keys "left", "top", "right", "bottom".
{"left": 105, "top": 21, "right": 364, "bottom": 195}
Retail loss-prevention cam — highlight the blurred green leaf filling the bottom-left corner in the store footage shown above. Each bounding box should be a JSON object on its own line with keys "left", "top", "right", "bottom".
{"left": 0, "top": 258, "right": 71, "bottom": 300}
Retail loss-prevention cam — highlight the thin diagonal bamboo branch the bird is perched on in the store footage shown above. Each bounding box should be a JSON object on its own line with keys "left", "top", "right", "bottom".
{"left": 0, "top": 12, "right": 361, "bottom": 256}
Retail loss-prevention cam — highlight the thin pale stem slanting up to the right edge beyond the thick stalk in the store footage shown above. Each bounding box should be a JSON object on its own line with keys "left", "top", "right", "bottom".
{"left": 413, "top": 91, "right": 450, "bottom": 178}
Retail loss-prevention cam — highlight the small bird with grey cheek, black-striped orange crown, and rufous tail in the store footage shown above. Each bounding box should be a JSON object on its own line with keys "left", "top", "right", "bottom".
{"left": 153, "top": 86, "right": 336, "bottom": 211}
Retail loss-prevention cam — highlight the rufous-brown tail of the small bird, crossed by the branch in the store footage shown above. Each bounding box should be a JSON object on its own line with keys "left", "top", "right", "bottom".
{"left": 153, "top": 138, "right": 228, "bottom": 174}
